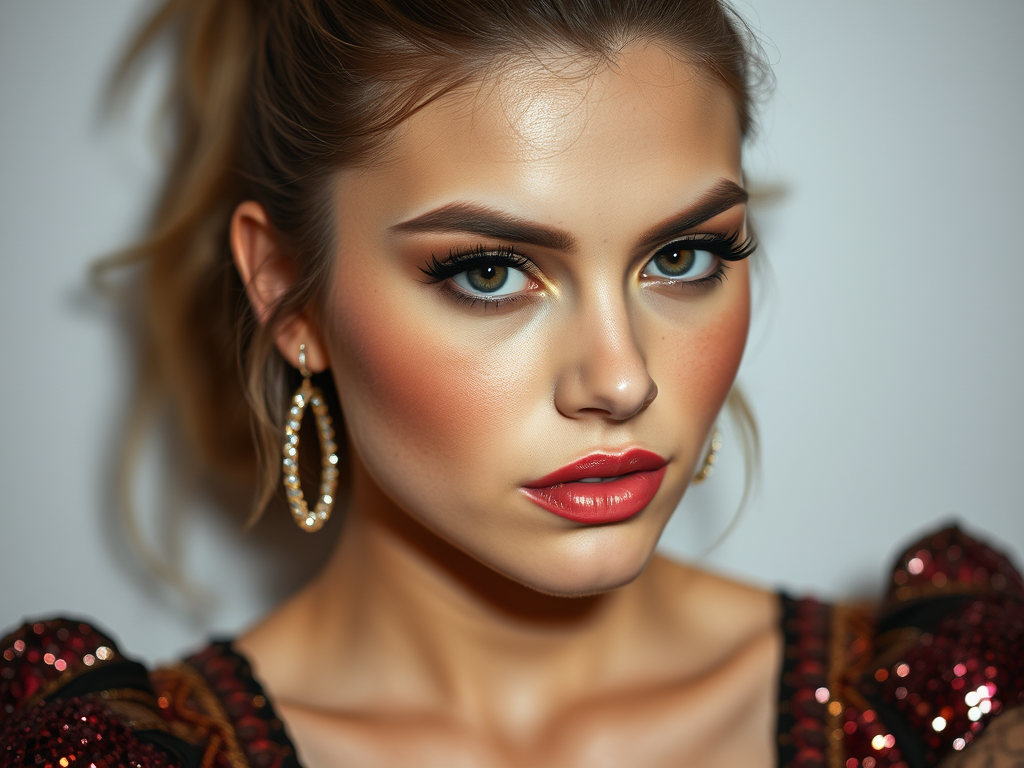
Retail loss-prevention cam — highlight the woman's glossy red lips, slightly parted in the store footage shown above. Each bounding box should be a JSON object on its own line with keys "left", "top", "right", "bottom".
{"left": 522, "top": 449, "right": 669, "bottom": 525}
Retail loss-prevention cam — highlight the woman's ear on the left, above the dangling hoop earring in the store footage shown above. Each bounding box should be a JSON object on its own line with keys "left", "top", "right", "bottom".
{"left": 230, "top": 200, "right": 331, "bottom": 373}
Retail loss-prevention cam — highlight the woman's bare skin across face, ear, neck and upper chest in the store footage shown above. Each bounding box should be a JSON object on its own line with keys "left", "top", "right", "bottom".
{"left": 231, "top": 45, "right": 780, "bottom": 768}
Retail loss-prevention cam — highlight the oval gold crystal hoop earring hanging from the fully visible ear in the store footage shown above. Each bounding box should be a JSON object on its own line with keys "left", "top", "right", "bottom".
{"left": 282, "top": 344, "right": 338, "bottom": 534}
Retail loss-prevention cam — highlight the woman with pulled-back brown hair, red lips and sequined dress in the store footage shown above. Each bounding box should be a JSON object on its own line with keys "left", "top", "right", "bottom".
{"left": 0, "top": 1, "right": 1024, "bottom": 768}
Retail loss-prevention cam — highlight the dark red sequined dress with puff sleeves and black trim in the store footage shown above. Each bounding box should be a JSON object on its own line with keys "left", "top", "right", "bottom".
{"left": 0, "top": 527, "right": 1024, "bottom": 768}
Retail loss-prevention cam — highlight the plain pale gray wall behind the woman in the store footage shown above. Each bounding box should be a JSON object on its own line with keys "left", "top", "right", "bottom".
{"left": 0, "top": 0, "right": 1024, "bottom": 658}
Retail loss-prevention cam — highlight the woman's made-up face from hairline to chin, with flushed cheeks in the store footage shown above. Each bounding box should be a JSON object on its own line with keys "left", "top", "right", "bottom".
{"left": 324, "top": 41, "right": 750, "bottom": 595}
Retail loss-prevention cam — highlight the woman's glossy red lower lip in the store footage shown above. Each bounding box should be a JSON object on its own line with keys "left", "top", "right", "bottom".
{"left": 522, "top": 467, "right": 668, "bottom": 525}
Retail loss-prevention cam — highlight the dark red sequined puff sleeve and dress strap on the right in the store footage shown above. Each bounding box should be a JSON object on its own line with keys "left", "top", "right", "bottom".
{"left": 780, "top": 526, "right": 1024, "bottom": 768}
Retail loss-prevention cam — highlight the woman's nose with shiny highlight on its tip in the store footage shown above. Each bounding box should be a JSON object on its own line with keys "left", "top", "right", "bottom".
{"left": 555, "top": 292, "right": 657, "bottom": 422}
